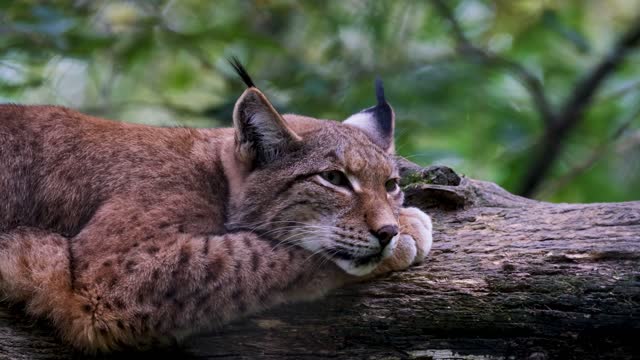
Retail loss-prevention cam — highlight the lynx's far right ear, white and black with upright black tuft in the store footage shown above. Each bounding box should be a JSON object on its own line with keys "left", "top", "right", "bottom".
{"left": 344, "top": 79, "right": 395, "bottom": 153}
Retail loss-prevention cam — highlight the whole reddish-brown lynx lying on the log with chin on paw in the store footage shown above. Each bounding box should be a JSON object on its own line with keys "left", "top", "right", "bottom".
{"left": 0, "top": 62, "right": 432, "bottom": 352}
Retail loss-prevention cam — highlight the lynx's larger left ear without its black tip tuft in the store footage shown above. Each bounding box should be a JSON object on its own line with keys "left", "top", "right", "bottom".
{"left": 233, "top": 87, "right": 301, "bottom": 166}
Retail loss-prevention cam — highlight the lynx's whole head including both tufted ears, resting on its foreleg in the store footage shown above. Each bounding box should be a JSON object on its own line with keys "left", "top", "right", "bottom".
{"left": 227, "top": 62, "right": 403, "bottom": 275}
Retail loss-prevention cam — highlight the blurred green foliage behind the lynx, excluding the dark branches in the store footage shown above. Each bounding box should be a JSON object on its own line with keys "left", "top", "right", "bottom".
{"left": 0, "top": 0, "right": 640, "bottom": 202}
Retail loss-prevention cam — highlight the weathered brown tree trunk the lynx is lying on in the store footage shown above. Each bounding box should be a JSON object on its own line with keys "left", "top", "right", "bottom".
{"left": 0, "top": 162, "right": 640, "bottom": 359}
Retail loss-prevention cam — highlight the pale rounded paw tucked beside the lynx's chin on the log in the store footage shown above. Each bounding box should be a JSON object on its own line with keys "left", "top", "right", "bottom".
{"left": 376, "top": 208, "right": 432, "bottom": 273}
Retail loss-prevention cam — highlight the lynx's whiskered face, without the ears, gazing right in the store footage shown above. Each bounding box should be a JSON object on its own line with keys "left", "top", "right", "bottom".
{"left": 229, "top": 120, "right": 403, "bottom": 275}
